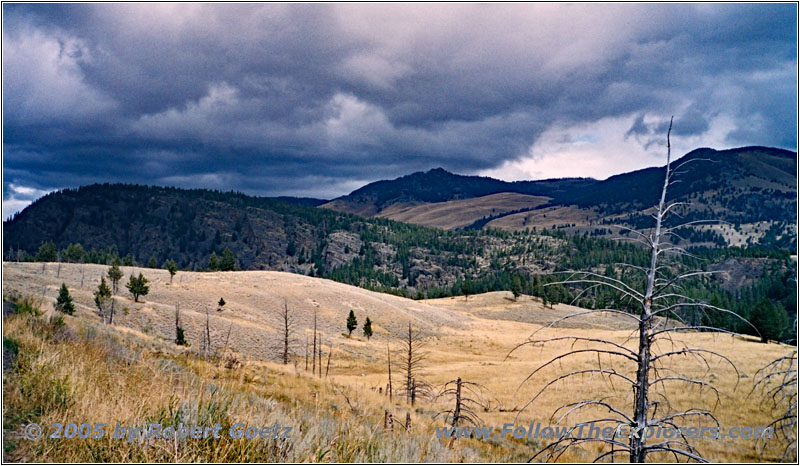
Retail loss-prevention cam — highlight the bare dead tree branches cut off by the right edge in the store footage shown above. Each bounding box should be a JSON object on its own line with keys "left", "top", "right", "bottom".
{"left": 751, "top": 349, "right": 798, "bottom": 463}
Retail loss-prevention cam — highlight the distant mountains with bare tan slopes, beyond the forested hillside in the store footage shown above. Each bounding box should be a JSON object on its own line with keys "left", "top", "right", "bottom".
{"left": 321, "top": 147, "right": 797, "bottom": 246}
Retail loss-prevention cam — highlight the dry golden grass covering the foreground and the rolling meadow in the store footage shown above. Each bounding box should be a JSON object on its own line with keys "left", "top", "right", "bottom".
{"left": 3, "top": 264, "right": 787, "bottom": 462}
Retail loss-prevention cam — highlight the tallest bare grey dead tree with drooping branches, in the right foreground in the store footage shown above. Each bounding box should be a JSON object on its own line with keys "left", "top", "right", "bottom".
{"left": 512, "top": 116, "right": 756, "bottom": 463}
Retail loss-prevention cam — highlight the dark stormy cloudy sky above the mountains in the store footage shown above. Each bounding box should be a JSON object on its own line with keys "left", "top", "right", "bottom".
{"left": 2, "top": 3, "right": 798, "bottom": 218}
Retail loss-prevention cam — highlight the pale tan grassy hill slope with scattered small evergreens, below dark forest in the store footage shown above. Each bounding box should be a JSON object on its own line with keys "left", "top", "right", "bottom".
{"left": 3, "top": 262, "right": 629, "bottom": 360}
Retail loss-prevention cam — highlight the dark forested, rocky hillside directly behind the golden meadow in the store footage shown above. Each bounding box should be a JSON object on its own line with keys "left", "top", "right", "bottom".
{"left": 4, "top": 185, "right": 796, "bottom": 338}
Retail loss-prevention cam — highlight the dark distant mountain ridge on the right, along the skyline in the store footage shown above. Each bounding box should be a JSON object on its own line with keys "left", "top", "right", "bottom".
{"left": 320, "top": 146, "right": 797, "bottom": 240}
